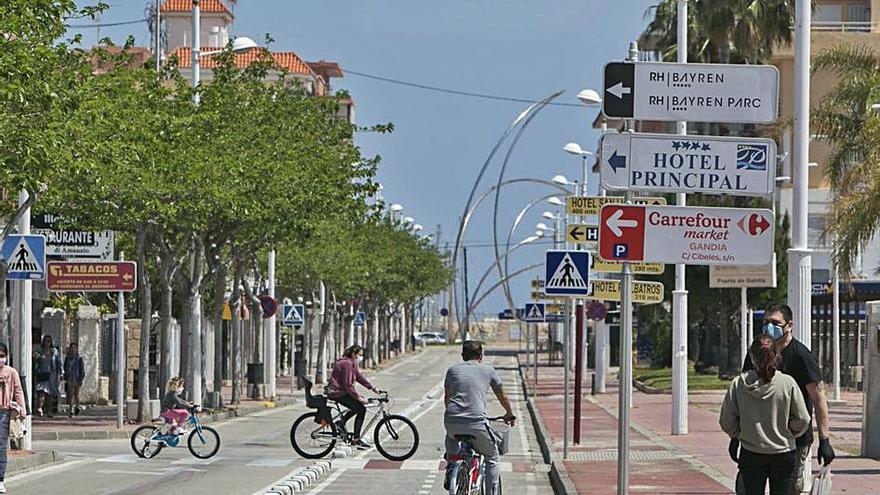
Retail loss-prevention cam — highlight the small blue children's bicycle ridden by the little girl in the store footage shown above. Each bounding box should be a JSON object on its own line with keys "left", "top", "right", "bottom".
{"left": 131, "top": 406, "right": 220, "bottom": 459}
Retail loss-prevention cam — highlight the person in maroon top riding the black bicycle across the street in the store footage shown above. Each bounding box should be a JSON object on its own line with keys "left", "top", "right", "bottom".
{"left": 326, "top": 345, "right": 379, "bottom": 450}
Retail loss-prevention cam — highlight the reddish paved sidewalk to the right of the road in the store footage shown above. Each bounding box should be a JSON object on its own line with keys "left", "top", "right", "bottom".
{"left": 521, "top": 359, "right": 880, "bottom": 495}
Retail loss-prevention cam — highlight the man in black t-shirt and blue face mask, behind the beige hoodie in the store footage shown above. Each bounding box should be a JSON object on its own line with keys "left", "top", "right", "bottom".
{"left": 728, "top": 304, "right": 835, "bottom": 495}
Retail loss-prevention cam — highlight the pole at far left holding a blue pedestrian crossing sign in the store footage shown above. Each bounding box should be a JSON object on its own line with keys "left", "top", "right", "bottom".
{"left": 10, "top": 190, "right": 34, "bottom": 450}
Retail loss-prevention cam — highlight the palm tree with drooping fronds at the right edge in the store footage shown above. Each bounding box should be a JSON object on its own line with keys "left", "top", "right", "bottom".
{"left": 812, "top": 45, "right": 880, "bottom": 276}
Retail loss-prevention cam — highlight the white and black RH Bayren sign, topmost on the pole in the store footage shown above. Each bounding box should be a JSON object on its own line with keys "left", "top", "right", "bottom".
{"left": 602, "top": 62, "right": 779, "bottom": 124}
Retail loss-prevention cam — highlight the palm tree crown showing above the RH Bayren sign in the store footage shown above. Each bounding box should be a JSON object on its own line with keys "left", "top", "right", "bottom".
{"left": 645, "top": 0, "right": 795, "bottom": 64}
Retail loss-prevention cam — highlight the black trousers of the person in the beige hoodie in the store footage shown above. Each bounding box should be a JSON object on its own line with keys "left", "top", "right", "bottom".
{"left": 739, "top": 449, "right": 798, "bottom": 495}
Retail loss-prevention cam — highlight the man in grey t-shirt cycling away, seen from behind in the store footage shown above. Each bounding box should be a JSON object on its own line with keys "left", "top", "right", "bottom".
{"left": 443, "top": 340, "right": 516, "bottom": 495}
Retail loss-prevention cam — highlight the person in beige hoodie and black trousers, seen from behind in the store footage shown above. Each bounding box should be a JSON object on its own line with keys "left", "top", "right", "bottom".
{"left": 719, "top": 334, "right": 810, "bottom": 495}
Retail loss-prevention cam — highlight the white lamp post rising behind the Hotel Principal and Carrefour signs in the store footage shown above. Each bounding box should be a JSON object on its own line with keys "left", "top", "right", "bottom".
{"left": 672, "top": 0, "right": 690, "bottom": 435}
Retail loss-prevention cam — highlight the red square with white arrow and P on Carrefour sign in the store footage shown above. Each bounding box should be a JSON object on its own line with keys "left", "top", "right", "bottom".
{"left": 599, "top": 205, "right": 645, "bottom": 261}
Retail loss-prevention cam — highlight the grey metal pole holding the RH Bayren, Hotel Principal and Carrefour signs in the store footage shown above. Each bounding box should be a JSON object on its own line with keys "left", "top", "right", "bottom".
{"left": 617, "top": 41, "right": 639, "bottom": 495}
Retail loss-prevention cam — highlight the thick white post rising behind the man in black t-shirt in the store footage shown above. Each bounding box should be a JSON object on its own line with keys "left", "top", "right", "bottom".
{"left": 788, "top": 0, "right": 813, "bottom": 349}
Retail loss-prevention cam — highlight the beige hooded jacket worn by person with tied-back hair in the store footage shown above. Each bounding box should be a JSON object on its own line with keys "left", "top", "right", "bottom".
{"left": 719, "top": 370, "right": 810, "bottom": 454}
